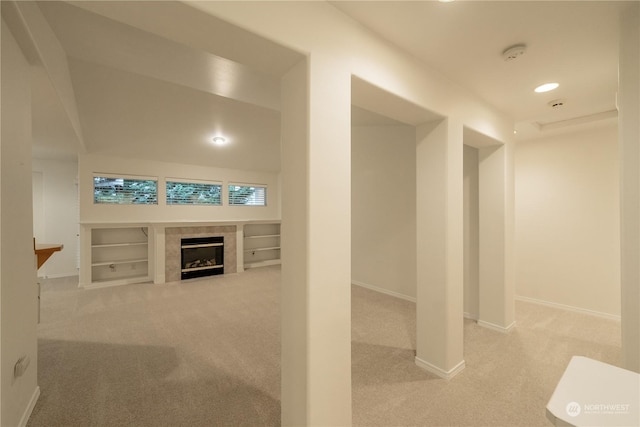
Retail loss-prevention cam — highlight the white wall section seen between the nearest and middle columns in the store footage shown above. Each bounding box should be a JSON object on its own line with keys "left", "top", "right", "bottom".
{"left": 351, "top": 126, "right": 416, "bottom": 301}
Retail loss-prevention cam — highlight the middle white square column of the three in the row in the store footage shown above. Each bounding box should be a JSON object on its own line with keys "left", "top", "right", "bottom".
{"left": 416, "top": 119, "right": 464, "bottom": 379}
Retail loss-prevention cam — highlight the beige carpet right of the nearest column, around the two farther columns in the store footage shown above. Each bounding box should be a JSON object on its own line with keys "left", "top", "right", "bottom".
{"left": 352, "top": 287, "right": 620, "bottom": 426}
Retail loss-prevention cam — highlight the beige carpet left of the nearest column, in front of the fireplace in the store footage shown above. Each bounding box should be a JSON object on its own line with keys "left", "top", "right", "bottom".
{"left": 28, "top": 269, "right": 280, "bottom": 426}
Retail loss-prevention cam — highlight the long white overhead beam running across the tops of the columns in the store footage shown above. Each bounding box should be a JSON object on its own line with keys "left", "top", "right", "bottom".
{"left": 188, "top": 1, "right": 513, "bottom": 143}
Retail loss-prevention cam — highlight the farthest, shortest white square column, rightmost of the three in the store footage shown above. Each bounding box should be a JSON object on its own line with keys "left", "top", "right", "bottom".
{"left": 478, "top": 144, "right": 515, "bottom": 332}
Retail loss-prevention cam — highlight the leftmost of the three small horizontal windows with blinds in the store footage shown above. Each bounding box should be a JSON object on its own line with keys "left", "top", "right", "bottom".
{"left": 93, "top": 175, "right": 158, "bottom": 205}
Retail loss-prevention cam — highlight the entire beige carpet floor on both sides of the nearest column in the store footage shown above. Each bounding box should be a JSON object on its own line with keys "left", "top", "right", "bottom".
{"left": 28, "top": 266, "right": 620, "bottom": 427}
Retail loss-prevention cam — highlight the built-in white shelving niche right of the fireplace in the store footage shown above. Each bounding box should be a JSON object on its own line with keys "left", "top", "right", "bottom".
{"left": 243, "top": 223, "right": 280, "bottom": 268}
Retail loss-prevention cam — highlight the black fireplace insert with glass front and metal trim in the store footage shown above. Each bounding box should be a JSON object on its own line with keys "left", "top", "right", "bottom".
{"left": 180, "top": 236, "right": 224, "bottom": 280}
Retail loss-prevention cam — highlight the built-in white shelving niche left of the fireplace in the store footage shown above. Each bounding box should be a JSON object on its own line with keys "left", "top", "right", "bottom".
{"left": 91, "top": 227, "right": 151, "bottom": 286}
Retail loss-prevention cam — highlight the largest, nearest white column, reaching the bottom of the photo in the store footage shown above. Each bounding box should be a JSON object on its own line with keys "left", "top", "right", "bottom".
{"left": 281, "top": 55, "right": 351, "bottom": 426}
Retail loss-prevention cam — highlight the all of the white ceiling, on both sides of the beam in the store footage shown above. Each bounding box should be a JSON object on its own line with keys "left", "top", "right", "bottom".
{"left": 28, "top": 1, "right": 624, "bottom": 171}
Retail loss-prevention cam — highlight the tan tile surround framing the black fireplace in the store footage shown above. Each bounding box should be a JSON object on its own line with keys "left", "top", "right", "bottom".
{"left": 165, "top": 225, "right": 238, "bottom": 282}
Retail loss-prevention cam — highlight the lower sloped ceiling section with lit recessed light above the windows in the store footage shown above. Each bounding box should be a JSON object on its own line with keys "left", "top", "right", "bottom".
{"left": 70, "top": 59, "right": 280, "bottom": 171}
